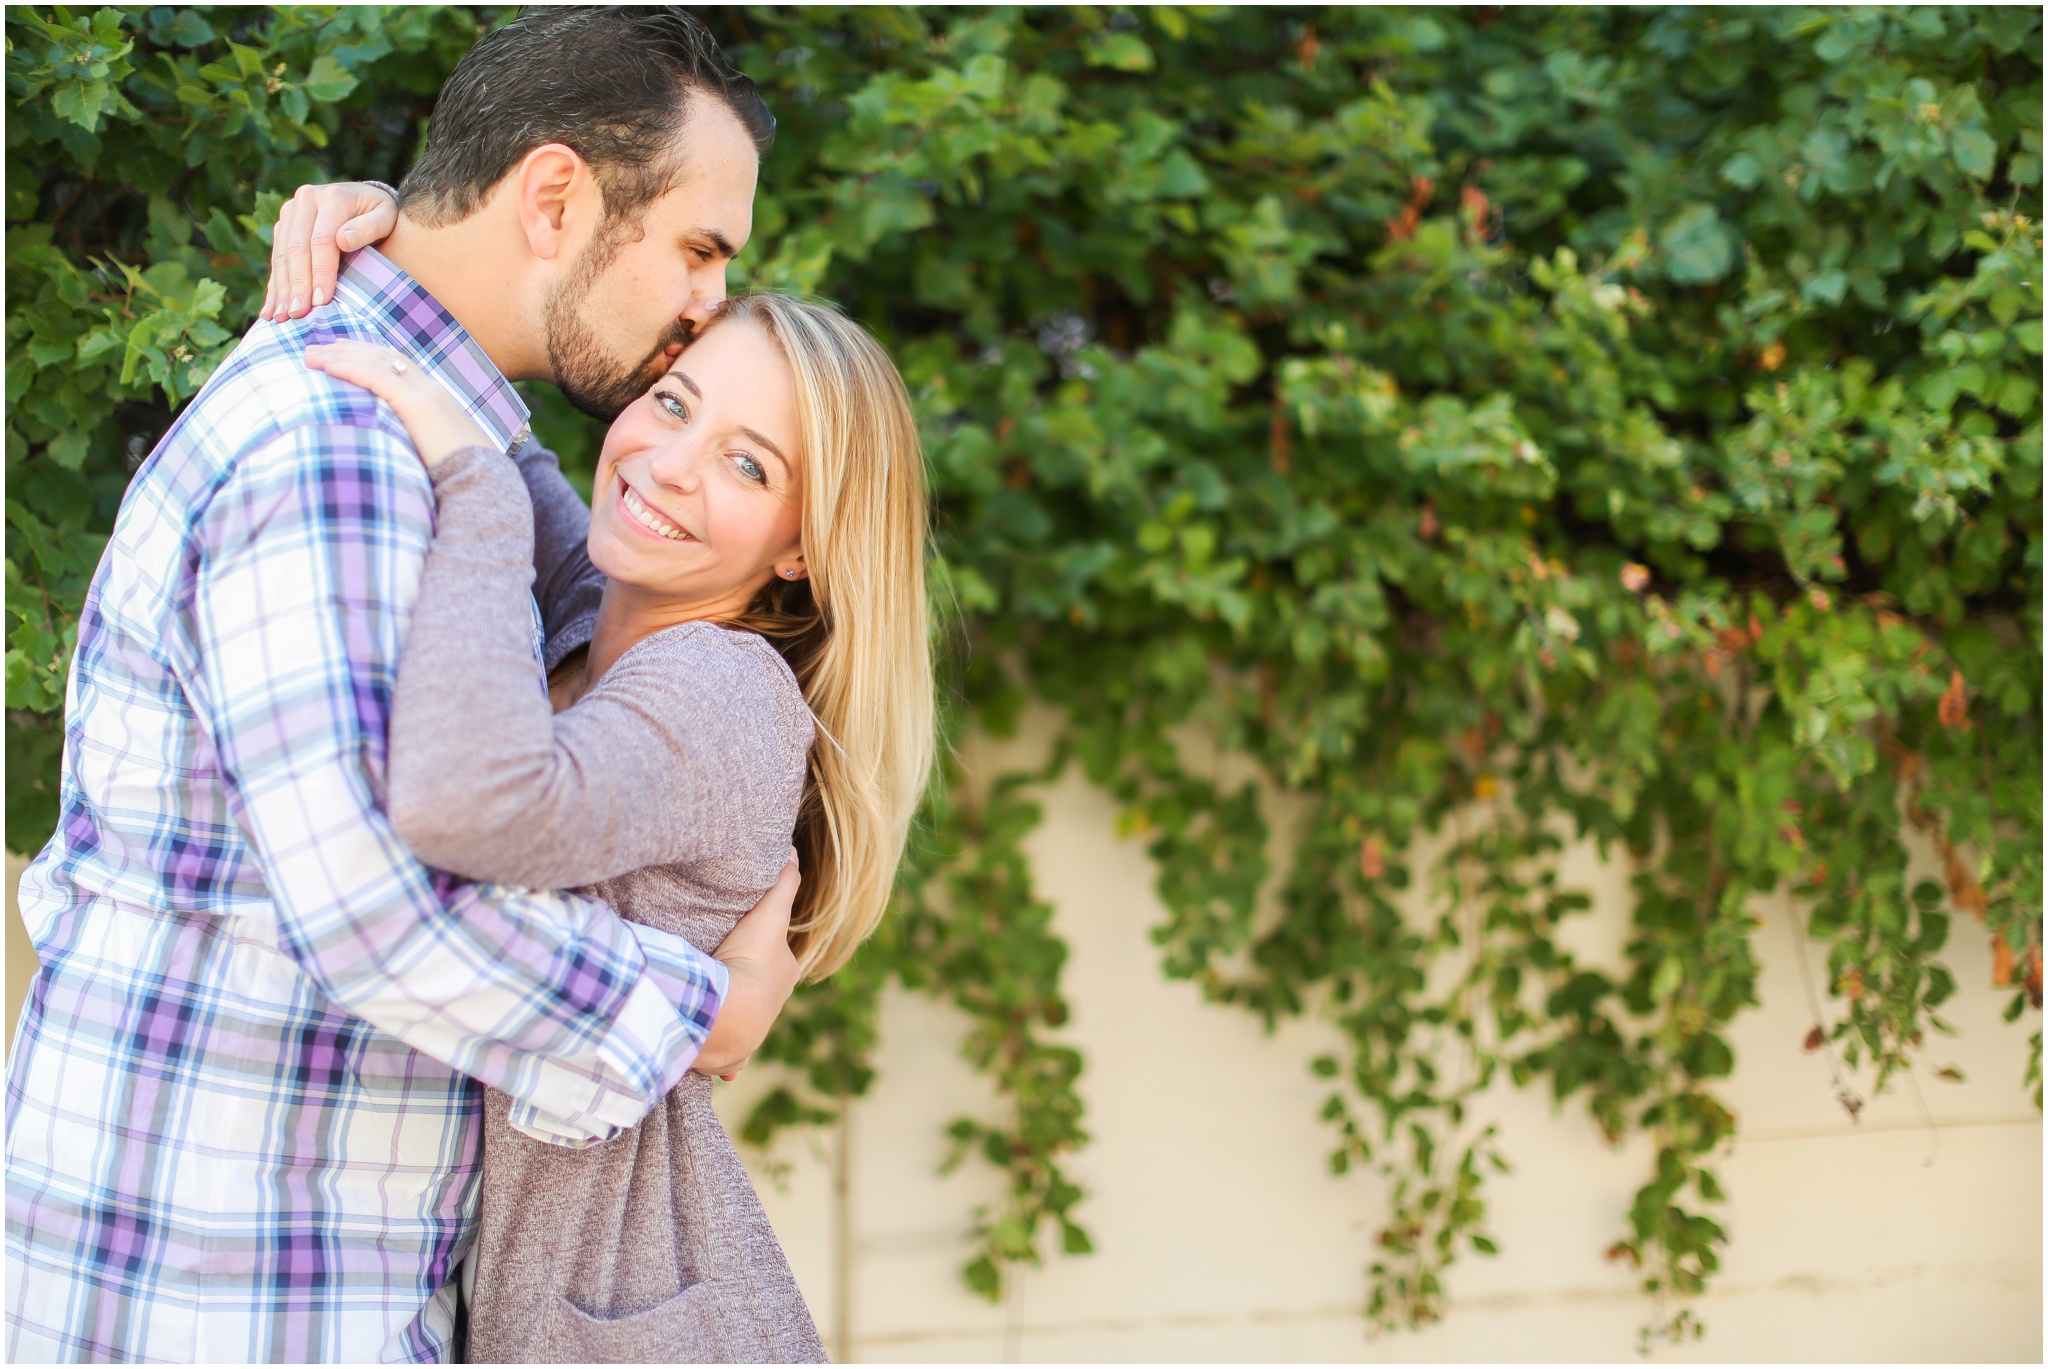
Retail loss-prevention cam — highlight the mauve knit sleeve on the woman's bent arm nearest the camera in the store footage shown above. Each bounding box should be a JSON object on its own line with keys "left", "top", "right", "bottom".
{"left": 391, "top": 438, "right": 811, "bottom": 887}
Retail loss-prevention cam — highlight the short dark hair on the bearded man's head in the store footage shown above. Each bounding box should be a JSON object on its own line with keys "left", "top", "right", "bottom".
{"left": 399, "top": 4, "right": 774, "bottom": 225}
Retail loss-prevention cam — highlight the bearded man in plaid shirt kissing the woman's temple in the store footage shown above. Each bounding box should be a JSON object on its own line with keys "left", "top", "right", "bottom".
{"left": 6, "top": 8, "right": 795, "bottom": 1361}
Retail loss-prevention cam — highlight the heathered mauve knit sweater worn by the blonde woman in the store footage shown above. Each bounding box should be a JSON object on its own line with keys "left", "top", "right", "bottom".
{"left": 389, "top": 443, "right": 825, "bottom": 1363}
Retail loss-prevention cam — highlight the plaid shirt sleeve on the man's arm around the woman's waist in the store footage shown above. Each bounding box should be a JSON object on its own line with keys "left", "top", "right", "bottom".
{"left": 184, "top": 424, "right": 727, "bottom": 1144}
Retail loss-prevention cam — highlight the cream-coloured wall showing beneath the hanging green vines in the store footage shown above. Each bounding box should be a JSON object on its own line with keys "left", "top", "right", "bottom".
{"left": 6, "top": 717, "right": 2042, "bottom": 1361}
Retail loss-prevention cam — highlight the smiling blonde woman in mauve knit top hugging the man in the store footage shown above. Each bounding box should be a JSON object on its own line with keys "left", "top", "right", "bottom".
{"left": 307, "top": 282, "right": 932, "bottom": 1361}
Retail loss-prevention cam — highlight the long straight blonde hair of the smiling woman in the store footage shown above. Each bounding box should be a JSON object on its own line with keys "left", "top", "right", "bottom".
{"left": 709, "top": 295, "right": 934, "bottom": 980}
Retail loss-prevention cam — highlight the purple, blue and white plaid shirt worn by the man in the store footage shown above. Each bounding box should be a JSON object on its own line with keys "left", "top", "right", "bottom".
{"left": 6, "top": 250, "right": 725, "bottom": 1361}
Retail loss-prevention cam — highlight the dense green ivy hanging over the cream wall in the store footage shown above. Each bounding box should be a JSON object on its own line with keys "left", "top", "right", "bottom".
{"left": 6, "top": 6, "right": 2042, "bottom": 1336}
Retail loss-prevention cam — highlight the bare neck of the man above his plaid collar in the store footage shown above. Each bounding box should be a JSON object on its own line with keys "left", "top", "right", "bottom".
{"left": 377, "top": 207, "right": 553, "bottom": 381}
